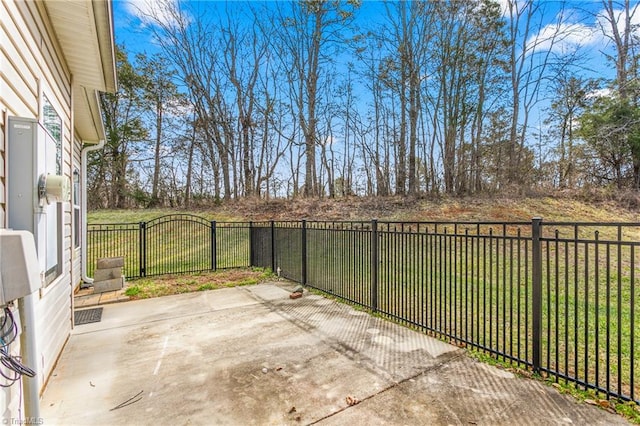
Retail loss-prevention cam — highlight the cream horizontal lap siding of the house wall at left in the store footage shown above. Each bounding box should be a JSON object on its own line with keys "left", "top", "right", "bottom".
{"left": 0, "top": 1, "right": 81, "bottom": 419}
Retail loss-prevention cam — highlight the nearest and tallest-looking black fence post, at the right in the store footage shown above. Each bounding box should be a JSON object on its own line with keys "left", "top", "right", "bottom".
{"left": 531, "top": 217, "right": 542, "bottom": 372}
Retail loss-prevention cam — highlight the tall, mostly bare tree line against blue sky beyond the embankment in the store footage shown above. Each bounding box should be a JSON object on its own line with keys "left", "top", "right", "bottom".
{"left": 88, "top": 0, "right": 640, "bottom": 208}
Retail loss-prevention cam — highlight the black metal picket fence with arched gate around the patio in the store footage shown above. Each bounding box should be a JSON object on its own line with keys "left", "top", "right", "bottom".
{"left": 88, "top": 215, "right": 640, "bottom": 402}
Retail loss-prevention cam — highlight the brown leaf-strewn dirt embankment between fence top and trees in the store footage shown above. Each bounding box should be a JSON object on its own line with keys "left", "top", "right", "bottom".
{"left": 203, "top": 193, "right": 640, "bottom": 222}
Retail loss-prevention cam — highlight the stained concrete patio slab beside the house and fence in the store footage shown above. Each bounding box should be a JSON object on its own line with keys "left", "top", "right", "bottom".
{"left": 41, "top": 283, "right": 626, "bottom": 425}
